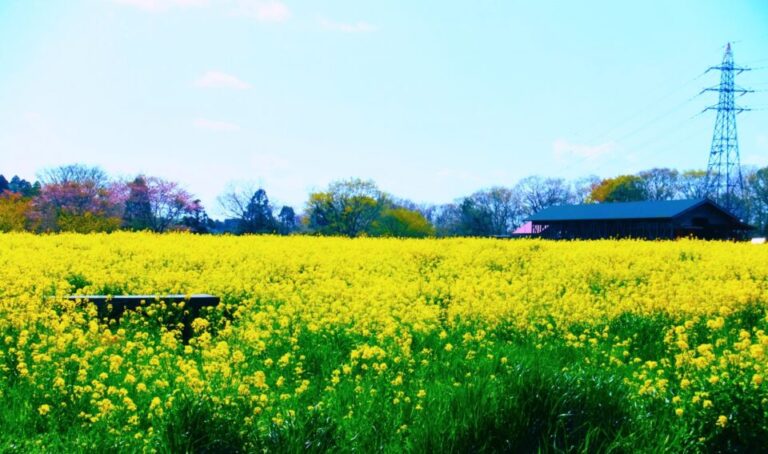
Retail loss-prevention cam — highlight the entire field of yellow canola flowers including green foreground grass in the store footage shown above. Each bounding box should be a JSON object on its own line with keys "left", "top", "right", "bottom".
{"left": 0, "top": 233, "right": 768, "bottom": 452}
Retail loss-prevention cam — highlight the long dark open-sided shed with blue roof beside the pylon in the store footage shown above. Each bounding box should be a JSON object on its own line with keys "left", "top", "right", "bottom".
{"left": 526, "top": 199, "right": 753, "bottom": 240}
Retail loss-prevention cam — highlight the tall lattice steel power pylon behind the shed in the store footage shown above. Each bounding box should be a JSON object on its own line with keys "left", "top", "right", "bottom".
{"left": 702, "top": 43, "right": 752, "bottom": 213}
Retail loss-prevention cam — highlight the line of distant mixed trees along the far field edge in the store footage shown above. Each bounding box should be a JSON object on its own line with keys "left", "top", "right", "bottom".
{"left": 0, "top": 164, "right": 768, "bottom": 238}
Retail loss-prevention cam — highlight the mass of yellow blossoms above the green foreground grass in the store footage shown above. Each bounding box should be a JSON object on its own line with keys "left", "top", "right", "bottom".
{"left": 0, "top": 232, "right": 768, "bottom": 450}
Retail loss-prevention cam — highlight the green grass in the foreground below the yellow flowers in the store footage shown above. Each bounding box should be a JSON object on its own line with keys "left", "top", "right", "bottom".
{"left": 0, "top": 307, "right": 768, "bottom": 453}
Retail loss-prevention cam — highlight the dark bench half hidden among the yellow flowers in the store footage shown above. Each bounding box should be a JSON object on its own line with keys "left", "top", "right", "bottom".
{"left": 66, "top": 294, "right": 220, "bottom": 344}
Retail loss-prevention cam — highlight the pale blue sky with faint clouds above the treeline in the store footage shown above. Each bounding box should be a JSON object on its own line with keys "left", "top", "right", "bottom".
{"left": 0, "top": 0, "right": 768, "bottom": 214}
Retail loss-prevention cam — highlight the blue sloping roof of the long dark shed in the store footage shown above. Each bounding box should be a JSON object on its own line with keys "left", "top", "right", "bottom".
{"left": 528, "top": 199, "right": 741, "bottom": 224}
